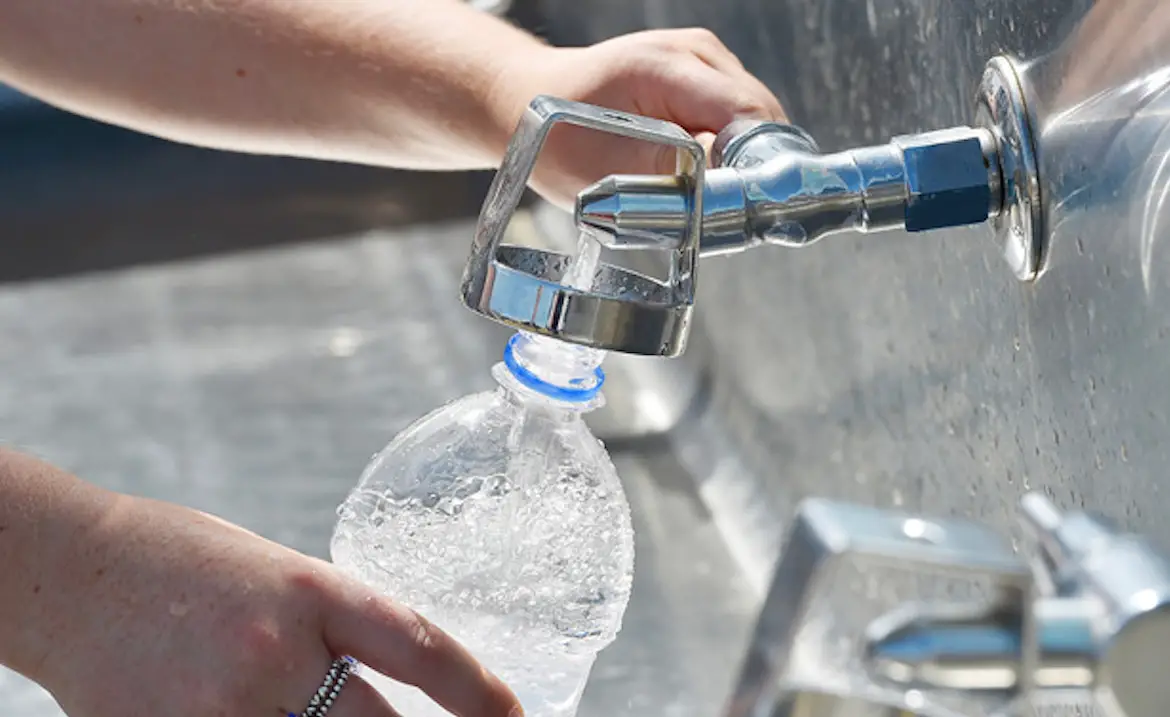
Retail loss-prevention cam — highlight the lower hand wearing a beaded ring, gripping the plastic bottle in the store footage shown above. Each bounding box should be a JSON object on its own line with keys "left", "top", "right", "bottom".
{"left": 37, "top": 497, "right": 519, "bottom": 717}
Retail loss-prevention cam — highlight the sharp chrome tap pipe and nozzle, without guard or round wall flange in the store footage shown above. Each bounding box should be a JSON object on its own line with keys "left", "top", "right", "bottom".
{"left": 576, "top": 122, "right": 1002, "bottom": 256}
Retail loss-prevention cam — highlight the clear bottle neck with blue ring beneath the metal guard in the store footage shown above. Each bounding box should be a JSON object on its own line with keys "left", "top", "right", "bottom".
{"left": 495, "top": 331, "right": 605, "bottom": 411}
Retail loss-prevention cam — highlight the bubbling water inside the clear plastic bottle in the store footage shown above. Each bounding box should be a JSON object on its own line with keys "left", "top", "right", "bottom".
{"left": 332, "top": 442, "right": 632, "bottom": 717}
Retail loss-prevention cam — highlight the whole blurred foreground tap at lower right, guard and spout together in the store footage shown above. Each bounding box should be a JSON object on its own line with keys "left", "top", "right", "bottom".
{"left": 724, "top": 492, "right": 1170, "bottom": 717}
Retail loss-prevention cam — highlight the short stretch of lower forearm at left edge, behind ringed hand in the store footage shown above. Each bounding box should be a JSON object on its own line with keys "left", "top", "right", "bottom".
{"left": 0, "top": 448, "right": 116, "bottom": 678}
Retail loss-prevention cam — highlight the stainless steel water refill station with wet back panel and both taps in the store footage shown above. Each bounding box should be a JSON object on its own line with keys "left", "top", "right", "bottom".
{"left": 0, "top": 0, "right": 1170, "bottom": 717}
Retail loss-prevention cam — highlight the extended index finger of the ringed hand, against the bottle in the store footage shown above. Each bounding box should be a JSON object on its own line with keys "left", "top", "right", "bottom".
{"left": 325, "top": 587, "right": 519, "bottom": 717}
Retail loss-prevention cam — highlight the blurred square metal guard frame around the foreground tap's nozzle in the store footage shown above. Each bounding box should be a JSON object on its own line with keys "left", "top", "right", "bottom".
{"left": 723, "top": 498, "right": 1033, "bottom": 717}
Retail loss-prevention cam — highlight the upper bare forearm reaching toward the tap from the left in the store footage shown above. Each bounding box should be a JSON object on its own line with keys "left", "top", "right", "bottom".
{"left": 0, "top": 0, "right": 545, "bottom": 168}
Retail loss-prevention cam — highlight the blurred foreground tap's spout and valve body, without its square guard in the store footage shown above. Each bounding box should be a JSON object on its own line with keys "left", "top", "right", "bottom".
{"left": 867, "top": 494, "right": 1170, "bottom": 717}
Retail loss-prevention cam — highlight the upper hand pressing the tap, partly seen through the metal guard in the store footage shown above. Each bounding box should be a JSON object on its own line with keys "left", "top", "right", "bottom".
{"left": 491, "top": 29, "right": 787, "bottom": 207}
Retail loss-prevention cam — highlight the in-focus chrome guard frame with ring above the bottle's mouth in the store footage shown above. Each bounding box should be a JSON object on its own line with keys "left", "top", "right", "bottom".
{"left": 461, "top": 96, "right": 707, "bottom": 357}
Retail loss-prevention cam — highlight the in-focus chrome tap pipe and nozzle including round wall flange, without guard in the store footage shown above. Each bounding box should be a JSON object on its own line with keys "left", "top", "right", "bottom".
{"left": 576, "top": 57, "right": 1042, "bottom": 280}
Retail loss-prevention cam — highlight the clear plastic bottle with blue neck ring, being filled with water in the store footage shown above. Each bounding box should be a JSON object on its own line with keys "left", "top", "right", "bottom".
{"left": 331, "top": 325, "right": 634, "bottom": 717}
